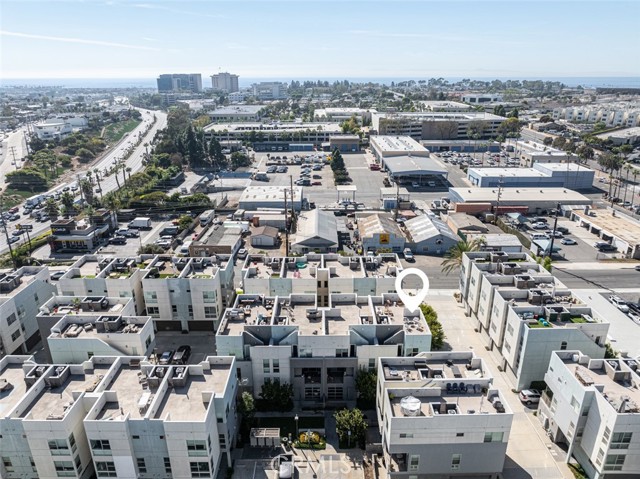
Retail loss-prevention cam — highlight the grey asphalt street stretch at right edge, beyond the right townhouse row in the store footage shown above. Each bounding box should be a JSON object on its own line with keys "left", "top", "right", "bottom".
{"left": 553, "top": 265, "right": 640, "bottom": 290}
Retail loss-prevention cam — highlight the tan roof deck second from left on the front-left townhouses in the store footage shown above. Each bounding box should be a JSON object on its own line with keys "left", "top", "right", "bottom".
{"left": 22, "top": 365, "right": 110, "bottom": 421}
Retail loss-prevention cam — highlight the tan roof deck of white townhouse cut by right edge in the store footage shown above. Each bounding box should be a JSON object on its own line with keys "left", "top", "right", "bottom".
{"left": 563, "top": 357, "right": 640, "bottom": 413}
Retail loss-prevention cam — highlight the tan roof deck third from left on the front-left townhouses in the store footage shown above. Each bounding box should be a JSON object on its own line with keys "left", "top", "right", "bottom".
{"left": 96, "top": 365, "right": 157, "bottom": 421}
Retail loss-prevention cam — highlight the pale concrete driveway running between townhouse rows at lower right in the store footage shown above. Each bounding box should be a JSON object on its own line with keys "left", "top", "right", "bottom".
{"left": 426, "top": 290, "right": 574, "bottom": 479}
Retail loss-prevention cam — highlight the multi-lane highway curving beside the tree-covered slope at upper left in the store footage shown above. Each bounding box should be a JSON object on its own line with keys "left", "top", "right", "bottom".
{"left": 0, "top": 109, "right": 167, "bottom": 254}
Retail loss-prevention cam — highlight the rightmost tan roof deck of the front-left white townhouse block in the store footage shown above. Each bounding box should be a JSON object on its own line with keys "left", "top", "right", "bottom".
{"left": 155, "top": 365, "right": 231, "bottom": 421}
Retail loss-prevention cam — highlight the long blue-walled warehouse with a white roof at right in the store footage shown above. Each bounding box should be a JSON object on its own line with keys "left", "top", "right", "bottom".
{"left": 467, "top": 162, "right": 595, "bottom": 190}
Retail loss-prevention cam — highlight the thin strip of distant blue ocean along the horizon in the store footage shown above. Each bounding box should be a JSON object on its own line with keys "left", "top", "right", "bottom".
{"left": 0, "top": 76, "right": 640, "bottom": 88}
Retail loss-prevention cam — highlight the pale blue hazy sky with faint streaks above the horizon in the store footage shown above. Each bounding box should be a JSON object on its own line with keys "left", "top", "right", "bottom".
{"left": 0, "top": 0, "right": 640, "bottom": 80}
